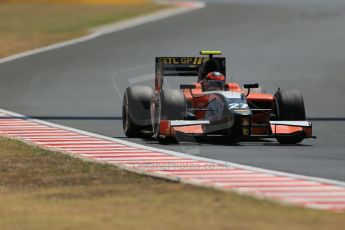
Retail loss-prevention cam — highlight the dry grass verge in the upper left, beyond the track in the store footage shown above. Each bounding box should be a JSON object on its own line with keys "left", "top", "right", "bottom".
{"left": 0, "top": 0, "right": 168, "bottom": 57}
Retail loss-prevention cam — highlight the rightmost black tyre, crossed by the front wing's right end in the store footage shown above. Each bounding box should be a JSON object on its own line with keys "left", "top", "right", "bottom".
{"left": 274, "top": 89, "right": 306, "bottom": 144}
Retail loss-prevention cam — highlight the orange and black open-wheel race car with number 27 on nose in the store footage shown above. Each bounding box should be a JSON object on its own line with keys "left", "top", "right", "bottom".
{"left": 122, "top": 51, "right": 314, "bottom": 144}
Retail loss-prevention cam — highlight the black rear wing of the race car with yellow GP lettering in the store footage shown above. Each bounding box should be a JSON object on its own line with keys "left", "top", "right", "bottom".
{"left": 155, "top": 53, "right": 226, "bottom": 91}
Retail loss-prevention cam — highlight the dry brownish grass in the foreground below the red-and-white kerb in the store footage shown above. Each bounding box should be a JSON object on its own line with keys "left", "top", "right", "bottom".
{"left": 0, "top": 138, "right": 345, "bottom": 230}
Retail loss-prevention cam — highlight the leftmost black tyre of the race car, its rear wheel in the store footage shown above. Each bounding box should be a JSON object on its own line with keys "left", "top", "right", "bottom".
{"left": 122, "top": 86, "right": 154, "bottom": 138}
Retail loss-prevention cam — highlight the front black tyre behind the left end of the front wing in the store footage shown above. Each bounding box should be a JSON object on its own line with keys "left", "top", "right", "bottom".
{"left": 153, "top": 89, "right": 186, "bottom": 144}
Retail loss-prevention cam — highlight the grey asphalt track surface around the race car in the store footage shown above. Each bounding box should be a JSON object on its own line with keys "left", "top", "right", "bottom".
{"left": 0, "top": 0, "right": 345, "bottom": 181}
